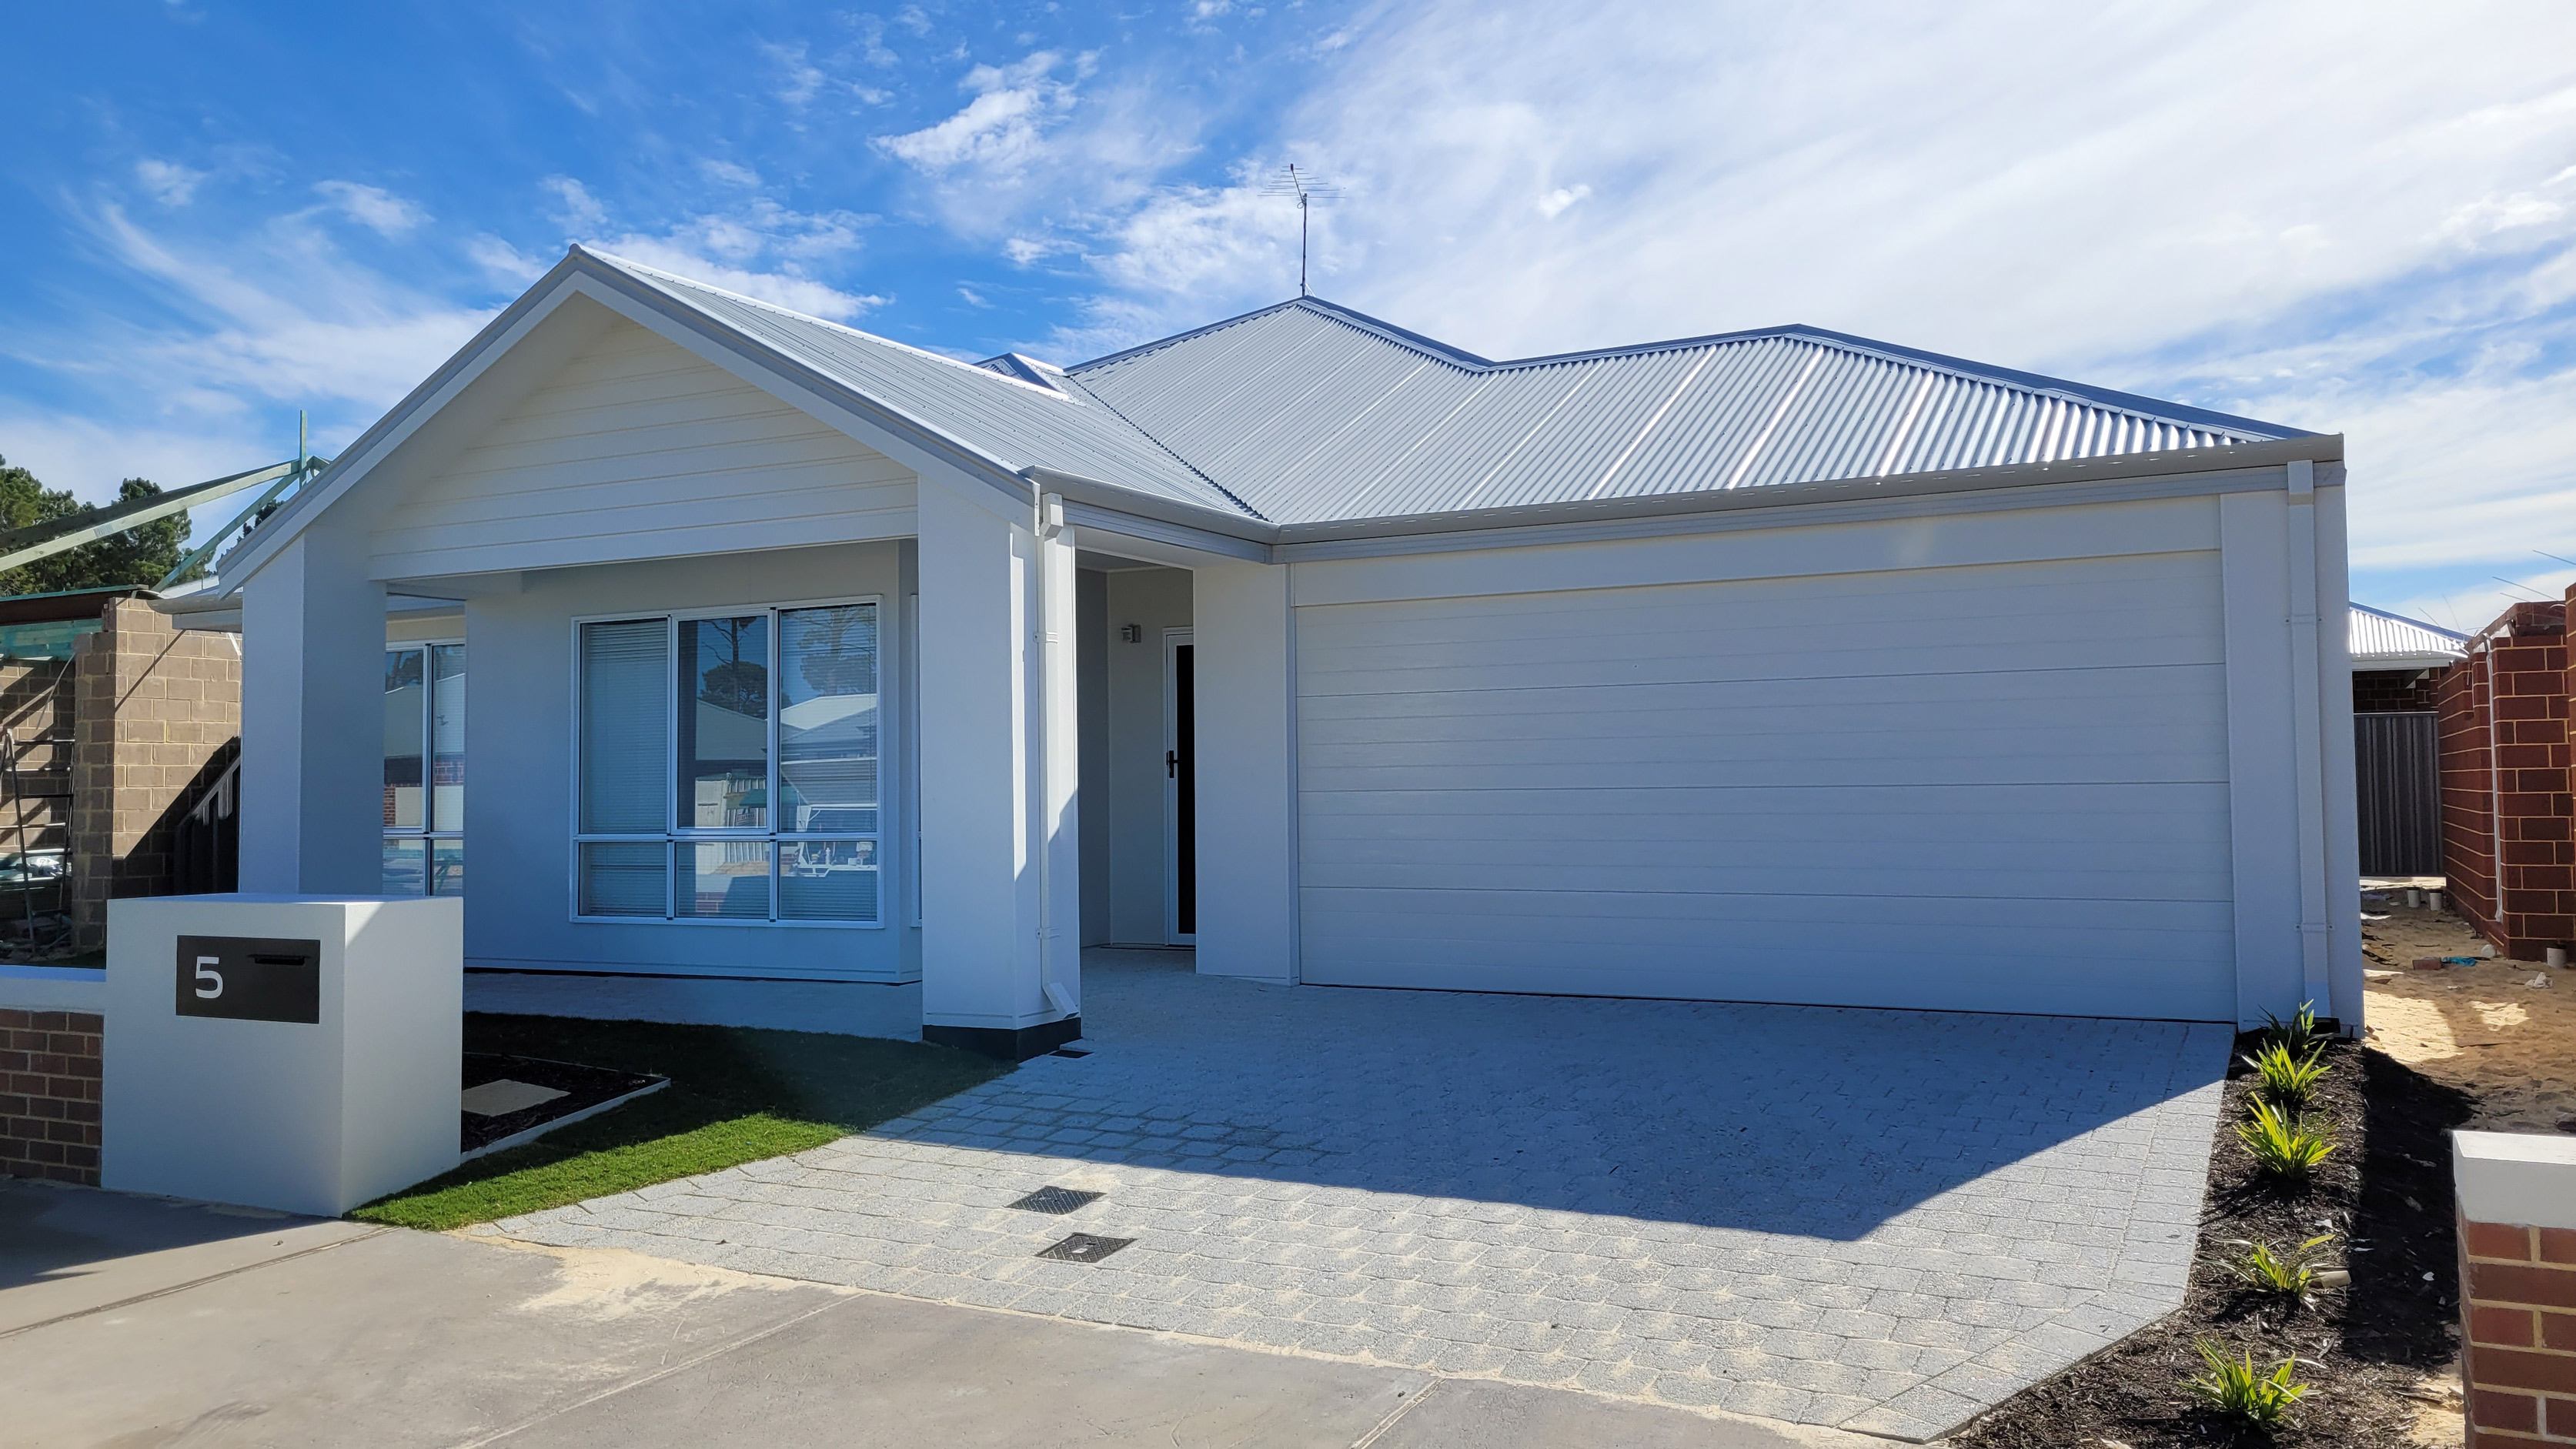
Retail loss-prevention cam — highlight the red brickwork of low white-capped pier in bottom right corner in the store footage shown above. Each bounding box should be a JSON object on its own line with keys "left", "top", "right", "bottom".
{"left": 2460, "top": 1217, "right": 2576, "bottom": 1449}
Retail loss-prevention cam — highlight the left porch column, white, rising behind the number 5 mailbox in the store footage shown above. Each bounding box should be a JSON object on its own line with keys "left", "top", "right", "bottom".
{"left": 242, "top": 528, "right": 384, "bottom": 896}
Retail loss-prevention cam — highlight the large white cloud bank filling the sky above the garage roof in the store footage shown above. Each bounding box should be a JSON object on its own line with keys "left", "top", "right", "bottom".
{"left": 984, "top": 0, "right": 2576, "bottom": 589}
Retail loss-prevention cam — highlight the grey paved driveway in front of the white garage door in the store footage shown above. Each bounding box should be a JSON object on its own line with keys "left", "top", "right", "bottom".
{"left": 487, "top": 952, "right": 2228, "bottom": 1439}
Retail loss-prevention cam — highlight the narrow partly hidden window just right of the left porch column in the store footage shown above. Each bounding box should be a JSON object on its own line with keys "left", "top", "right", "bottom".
{"left": 384, "top": 643, "right": 466, "bottom": 896}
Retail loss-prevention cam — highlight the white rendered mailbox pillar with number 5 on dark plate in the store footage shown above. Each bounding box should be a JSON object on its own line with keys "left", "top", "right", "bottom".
{"left": 101, "top": 896, "right": 463, "bottom": 1217}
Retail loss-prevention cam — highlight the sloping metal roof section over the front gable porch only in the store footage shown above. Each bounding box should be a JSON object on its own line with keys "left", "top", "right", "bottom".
{"left": 590, "top": 252, "right": 1245, "bottom": 515}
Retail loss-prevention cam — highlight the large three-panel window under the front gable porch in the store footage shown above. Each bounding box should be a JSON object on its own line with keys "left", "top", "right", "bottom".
{"left": 572, "top": 599, "right": 881, "bottom": 926}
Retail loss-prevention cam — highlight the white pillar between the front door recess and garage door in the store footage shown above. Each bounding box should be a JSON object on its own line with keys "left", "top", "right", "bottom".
{"left": 1190, "top": 563, "right": 1298, "bottom": 980}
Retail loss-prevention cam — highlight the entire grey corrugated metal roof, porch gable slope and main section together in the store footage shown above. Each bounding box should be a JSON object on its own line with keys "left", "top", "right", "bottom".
{"left": 600, "top": 257, "right": 2300, "bottom": 525}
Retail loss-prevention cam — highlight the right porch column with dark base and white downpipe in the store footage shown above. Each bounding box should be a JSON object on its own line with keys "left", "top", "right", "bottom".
{"left": 917, "top": 479, "right": 1082, "bottom": 1060}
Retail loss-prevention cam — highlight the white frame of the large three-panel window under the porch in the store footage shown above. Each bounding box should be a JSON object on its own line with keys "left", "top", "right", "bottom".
{"left": 564, "top": 595, "right": 901, "bottom": 932}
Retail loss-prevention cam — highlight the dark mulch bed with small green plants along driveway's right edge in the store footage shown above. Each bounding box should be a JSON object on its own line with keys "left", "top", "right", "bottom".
{"left": 1953, "top": 1037, "right": 2473, "bottom": 1449}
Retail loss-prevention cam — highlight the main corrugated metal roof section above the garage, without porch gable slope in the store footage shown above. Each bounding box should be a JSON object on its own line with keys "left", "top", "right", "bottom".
{"left": 1067, "top": 299, "right": 2306, "bottom": 523}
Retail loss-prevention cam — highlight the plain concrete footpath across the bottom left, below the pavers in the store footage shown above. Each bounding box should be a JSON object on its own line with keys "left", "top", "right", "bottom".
{"left": 0, "top": 1179, "right": 1883, "bottom": 1449}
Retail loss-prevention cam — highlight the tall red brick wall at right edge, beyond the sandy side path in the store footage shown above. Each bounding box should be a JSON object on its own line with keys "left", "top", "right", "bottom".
{"left": 2442, "top": 589, "right": 2576, "bottom": 960}
